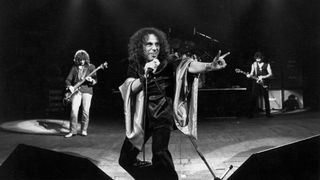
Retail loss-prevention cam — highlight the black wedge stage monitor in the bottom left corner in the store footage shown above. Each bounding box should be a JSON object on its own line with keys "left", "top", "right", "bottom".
{"left": 0, "top": 144, "right": 111, "bottom": 180}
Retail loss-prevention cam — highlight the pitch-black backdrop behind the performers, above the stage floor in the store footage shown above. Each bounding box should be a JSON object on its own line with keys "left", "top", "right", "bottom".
{"left": 0, "top": 0, "right": 320, "bottom": 119}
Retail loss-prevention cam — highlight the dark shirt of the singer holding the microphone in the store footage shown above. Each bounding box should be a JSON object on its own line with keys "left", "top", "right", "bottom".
{"left": 127, "top": 60, "right": 177, "bottom": 130}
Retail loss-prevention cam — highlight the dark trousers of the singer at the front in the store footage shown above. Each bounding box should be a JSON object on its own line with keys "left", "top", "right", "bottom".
{"left": 119, "top": 128, "right": 178, "bottom": 180}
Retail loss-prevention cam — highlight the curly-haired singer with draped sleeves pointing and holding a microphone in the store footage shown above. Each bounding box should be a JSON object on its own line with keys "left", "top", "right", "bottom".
{"left": 119, "top": 27, "right": 229, "bottom": 180}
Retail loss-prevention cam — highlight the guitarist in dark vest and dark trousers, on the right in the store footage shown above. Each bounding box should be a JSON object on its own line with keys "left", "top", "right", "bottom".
{"left": 247, "top": 51, "right": 272, "bottom": 117}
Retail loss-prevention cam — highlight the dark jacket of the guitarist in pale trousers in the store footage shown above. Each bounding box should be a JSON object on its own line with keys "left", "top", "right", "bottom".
{"left": 65, "top": 64, "right": 97, "bottom": 94}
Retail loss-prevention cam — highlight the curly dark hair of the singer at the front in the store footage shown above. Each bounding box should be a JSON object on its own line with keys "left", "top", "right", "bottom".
{"left": 128, "top": 27, "right": 170, "bottom": 67}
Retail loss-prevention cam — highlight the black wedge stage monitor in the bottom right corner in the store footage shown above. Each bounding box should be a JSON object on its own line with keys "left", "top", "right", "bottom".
{"left": 228, "top": 136, "right": 320, "bottom": 180}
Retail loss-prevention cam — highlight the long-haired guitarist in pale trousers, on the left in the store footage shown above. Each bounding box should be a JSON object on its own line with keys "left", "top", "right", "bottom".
{"left": 65, "top": 50, "right": 97, "bottom": 138}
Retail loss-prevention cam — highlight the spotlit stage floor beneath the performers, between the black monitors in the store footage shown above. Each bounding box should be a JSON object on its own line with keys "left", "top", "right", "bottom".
{"left": 0, "top": 111, "right": 320, "bottom": 180}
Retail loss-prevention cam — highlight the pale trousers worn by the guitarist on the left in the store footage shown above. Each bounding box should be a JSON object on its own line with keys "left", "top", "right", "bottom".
{"left": 70, "top": 92, "right": 92, "bottom": 134}
